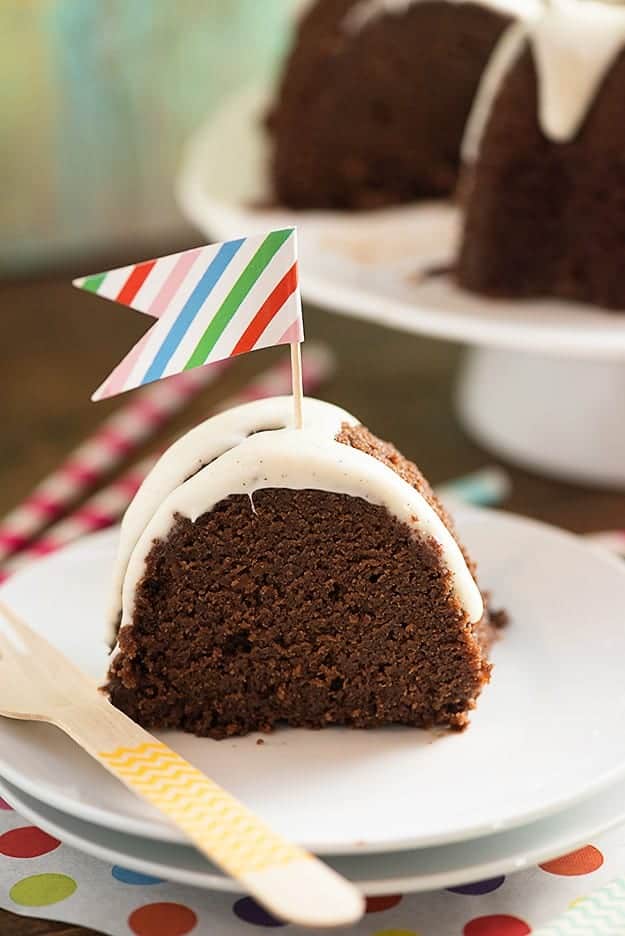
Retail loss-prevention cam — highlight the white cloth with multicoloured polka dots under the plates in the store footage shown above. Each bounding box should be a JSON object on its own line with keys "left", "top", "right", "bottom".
{"left": 0, "top": 799, "right": 625, "bottom": 936}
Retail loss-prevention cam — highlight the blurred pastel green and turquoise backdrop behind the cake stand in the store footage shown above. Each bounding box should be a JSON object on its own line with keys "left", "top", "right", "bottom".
{"left": 0, "top": 0, "right": 298, "bottom": 275}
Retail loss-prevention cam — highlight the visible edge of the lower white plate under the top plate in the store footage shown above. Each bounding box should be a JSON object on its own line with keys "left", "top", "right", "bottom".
{"left": 0, "top": 778, "right": 625, "bottom": 896}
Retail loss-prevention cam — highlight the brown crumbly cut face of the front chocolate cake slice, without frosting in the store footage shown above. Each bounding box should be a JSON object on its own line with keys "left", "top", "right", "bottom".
{"left": 109, "top": 489, "right": 490, "bottom": 738}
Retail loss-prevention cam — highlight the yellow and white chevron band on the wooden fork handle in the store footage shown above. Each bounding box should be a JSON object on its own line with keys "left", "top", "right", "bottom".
{"left": 98, "top": 742, "right": 309, "bottom": 876}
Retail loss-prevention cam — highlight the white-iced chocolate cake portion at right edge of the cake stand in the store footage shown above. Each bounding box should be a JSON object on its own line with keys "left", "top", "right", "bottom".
{"left": 457, "top": 0, "right": 625, "bottom": 309}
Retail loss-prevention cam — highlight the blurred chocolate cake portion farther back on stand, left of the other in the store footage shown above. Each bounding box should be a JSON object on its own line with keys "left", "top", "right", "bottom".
{"left": 268, "top": 0, "right": 539, "bottom": 209}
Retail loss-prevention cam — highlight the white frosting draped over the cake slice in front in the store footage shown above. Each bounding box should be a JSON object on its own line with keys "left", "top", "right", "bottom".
{"left": 111, "top": 397, "right": 483, "bottom": 656}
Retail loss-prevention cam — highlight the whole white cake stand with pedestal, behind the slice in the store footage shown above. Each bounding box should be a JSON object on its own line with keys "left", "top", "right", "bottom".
{"left": 177, "top": 89, "right": 625, "bottom": 487}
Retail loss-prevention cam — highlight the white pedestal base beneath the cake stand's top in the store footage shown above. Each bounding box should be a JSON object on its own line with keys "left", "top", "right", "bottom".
{"left": 456, "top": 348, "right": 625, "bottom": 487}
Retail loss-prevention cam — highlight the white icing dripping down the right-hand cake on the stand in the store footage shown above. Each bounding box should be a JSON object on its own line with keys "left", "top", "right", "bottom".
{"left": 462, "top": 0, "right": 625, "bottom": 161}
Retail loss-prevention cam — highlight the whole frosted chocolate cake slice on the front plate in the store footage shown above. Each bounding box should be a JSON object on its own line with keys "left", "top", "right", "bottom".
{"left": 107, "top": 397, "right": 496, "bottom": 738}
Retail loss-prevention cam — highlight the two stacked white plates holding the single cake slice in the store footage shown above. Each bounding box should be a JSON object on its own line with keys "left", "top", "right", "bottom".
{"left": 0, "top": 509, "right": 625, "bottom": 894}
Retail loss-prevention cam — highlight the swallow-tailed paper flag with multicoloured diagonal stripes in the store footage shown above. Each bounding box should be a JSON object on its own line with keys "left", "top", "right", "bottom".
{"left": 74, "top": 228, "right": 304, "bottom": 400}
